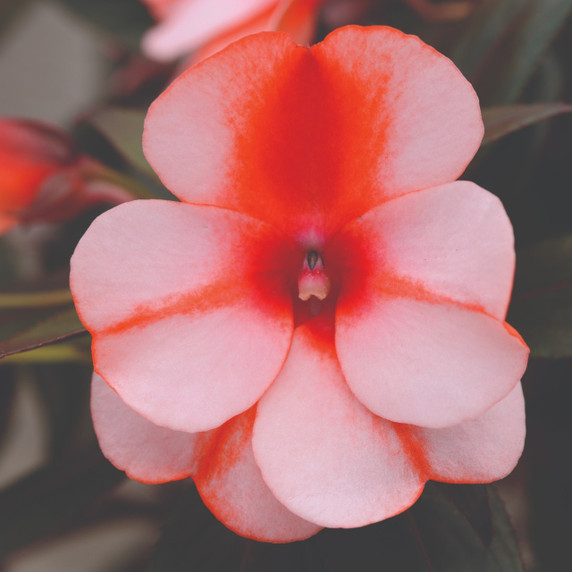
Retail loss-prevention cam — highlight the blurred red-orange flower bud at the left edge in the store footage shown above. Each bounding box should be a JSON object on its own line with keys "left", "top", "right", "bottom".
{"left": 0, "top": 118, "right": 132, "bottom": 234}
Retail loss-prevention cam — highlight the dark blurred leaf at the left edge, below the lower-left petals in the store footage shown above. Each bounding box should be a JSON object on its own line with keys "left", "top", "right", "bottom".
{"left": 0, "top": 451, "right": 124, "bottom": 558}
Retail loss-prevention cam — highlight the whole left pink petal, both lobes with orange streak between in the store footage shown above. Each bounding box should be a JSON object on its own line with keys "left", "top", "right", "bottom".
{"left": 71, "top": 201, "right": 292, "bottom": 432}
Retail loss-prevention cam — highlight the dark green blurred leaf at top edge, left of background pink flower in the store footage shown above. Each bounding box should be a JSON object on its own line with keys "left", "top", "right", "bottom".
{"left": 56, "top": 0, "right": 154, "bottom": 49}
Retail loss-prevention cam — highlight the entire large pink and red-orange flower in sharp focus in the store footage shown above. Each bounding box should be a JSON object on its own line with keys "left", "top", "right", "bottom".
{"left": 71, "top": 27, "right": 528, "bottom": 542}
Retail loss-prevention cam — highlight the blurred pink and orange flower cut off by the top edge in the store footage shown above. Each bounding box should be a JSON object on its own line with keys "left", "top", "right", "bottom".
{"left": 142, "top": 0, "right": 326, "bottom": 62}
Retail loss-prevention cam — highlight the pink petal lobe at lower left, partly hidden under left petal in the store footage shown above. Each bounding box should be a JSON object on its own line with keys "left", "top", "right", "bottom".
{"left": 91, "top": 373, "right": 197, "bottom": 483}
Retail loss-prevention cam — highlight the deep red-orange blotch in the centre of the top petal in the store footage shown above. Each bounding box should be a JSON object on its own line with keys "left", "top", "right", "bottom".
{"left": 228, "top": 42, "right": 394, "bottom": 236}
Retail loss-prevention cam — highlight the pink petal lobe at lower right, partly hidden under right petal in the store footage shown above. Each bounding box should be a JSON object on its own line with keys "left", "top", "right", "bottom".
{"left": 413, "top": 383, "right": 526, "bottom": 483}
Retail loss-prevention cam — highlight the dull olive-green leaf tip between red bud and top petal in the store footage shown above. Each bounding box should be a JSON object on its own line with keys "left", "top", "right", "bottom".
{"left": 88, "top": 107, "right": 155, "bottom": 177}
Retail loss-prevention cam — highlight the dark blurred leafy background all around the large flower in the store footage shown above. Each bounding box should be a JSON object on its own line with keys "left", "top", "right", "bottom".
{"left": 0, "top": 0, "right": 572, "bottom": 572}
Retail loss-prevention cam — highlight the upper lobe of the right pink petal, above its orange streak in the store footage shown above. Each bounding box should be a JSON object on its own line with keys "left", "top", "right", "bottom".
{"left": 333, "top": 181, "right": 515, "bottom": 320}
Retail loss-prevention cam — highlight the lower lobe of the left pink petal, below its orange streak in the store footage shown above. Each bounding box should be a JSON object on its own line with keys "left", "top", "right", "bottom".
{"left": 93, "top": 300, "right": 292, "bottom": 432}
